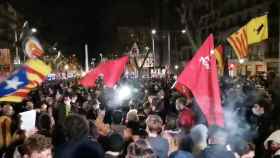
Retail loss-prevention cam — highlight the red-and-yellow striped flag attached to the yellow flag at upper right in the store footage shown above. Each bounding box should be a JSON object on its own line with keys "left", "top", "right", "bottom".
{"left": 227, "top": 27, "right": 249, "bottom": 60}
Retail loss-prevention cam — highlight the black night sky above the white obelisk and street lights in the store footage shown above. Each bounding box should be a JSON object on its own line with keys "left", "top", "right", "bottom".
{"left": 11, "top": 0, "right": 152, "bottom": 60}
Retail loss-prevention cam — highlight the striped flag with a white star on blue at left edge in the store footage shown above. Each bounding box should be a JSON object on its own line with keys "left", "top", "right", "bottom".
{"left": 0, "top": 59, "right": 51, "bottom": 102}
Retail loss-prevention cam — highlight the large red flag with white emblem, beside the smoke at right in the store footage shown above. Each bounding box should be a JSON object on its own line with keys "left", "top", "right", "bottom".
{"left": 177, "top": 34, "right": 224, "bottom": 126}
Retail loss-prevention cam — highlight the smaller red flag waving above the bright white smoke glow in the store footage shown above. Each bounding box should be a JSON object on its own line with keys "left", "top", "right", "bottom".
{"left": 80, "top": 56, "right": 128, "bottom": 88}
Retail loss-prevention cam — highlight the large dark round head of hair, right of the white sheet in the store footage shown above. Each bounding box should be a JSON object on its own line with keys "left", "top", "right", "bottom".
{"left": 63, "top": 114, "right": 89, "bottom": 141}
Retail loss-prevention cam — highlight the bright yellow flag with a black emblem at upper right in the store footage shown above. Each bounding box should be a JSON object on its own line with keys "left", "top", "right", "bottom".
{"left": 245, "top": 15, "right": 268, "bottom": 44}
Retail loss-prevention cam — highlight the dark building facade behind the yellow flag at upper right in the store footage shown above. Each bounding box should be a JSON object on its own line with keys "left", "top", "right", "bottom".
{"left": 199, "top": 0, "right": 279, "bottom": 75}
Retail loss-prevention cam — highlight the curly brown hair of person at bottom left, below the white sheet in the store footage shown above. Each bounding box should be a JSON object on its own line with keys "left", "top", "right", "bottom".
{"left": 23, "top": 134, "right": 53, "bottom": 155}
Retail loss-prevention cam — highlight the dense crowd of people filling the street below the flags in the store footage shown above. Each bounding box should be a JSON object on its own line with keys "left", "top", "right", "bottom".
{"left": 0, "top": 73, "right": 280, "bottom": 158}
